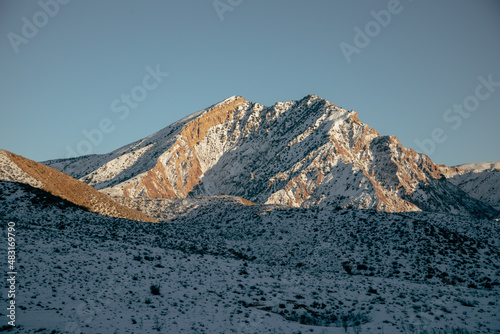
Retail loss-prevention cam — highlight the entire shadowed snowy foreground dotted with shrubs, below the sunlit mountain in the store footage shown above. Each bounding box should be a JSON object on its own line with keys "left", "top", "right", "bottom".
{"left": 0, "top": 181, "right": 500, "bottom": 334}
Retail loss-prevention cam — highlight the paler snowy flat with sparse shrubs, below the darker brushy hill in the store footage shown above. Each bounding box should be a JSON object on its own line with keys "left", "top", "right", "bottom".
{"left": 0, "top": 219, "right": 500, "bottom": 333}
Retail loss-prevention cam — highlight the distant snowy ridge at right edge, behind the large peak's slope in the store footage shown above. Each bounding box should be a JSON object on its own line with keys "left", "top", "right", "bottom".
{"left": 449, "top": 162, "right": 500, "bottom": 210}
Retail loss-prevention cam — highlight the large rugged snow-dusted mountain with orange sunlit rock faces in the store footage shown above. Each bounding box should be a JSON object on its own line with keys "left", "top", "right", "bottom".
{"left": 45, "top": 95, "right": 498, "bottom": 218}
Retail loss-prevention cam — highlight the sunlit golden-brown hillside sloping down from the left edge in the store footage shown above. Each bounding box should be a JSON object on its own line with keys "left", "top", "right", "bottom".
{"left": 0, "top": 150, "right": 155, "bottom": 222}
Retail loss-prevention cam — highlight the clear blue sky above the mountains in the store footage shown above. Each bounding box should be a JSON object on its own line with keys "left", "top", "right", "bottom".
{"left": 0, "top": 0, "right": 500, "bottom": 165}
